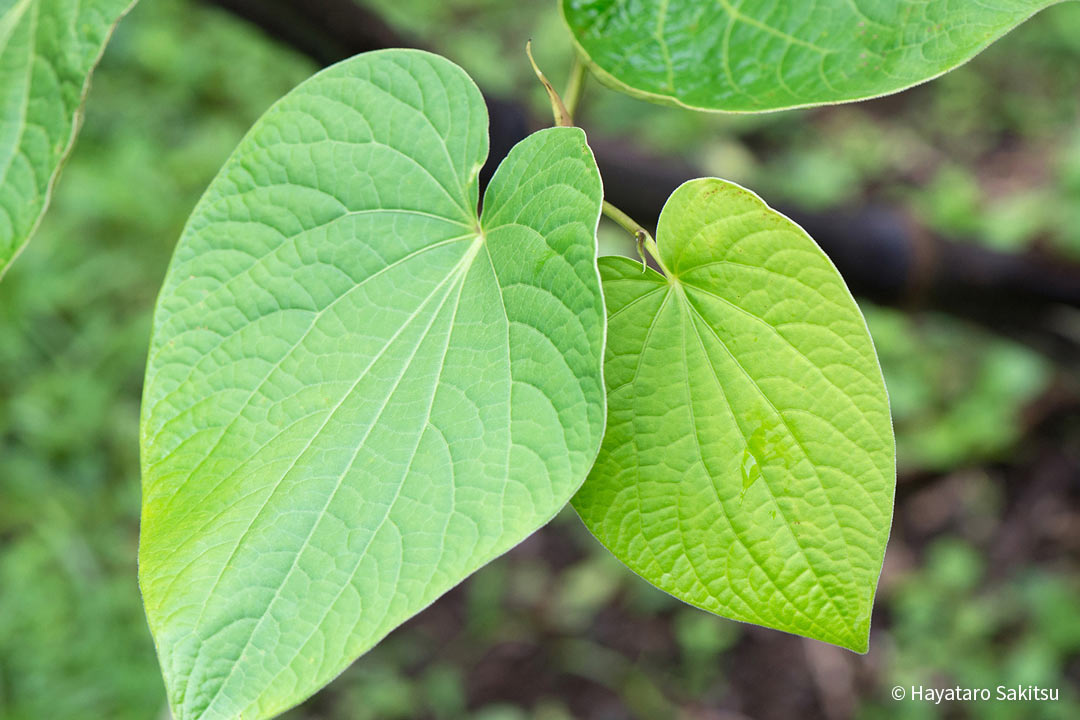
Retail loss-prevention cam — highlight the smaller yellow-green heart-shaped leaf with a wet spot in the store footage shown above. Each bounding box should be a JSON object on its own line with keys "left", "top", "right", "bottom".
{"left": 573, "top": 179, "right": 895, "bottom": 651}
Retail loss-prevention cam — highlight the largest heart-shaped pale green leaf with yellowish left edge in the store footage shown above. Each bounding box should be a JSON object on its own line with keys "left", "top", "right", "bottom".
{"left": 139, "top": 51, "right": 605, "bottom": 720}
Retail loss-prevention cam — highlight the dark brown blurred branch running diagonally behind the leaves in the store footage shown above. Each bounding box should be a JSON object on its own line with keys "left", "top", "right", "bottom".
{"left": 198, "top": 0, "right": 1080, "bottom": 368}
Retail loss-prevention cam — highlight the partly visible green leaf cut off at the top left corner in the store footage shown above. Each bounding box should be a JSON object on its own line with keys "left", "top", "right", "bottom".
{"left": 0, "top": 0, "right": 134, "bottom": 277}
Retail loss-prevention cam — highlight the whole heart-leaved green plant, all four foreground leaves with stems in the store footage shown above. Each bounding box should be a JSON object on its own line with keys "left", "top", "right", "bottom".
{"left": 0, "top": 0, "right": 1053, "bottom": 720}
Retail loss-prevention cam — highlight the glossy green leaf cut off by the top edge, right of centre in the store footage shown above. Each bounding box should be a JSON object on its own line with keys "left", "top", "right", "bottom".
{"left": 561, "top": 0, "right": 1061, "bottom": 112}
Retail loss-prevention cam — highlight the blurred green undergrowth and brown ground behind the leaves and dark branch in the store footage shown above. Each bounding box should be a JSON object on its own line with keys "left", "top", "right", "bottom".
{"left": 0, "top": 0, "right": 1080, "bottom": 720}
